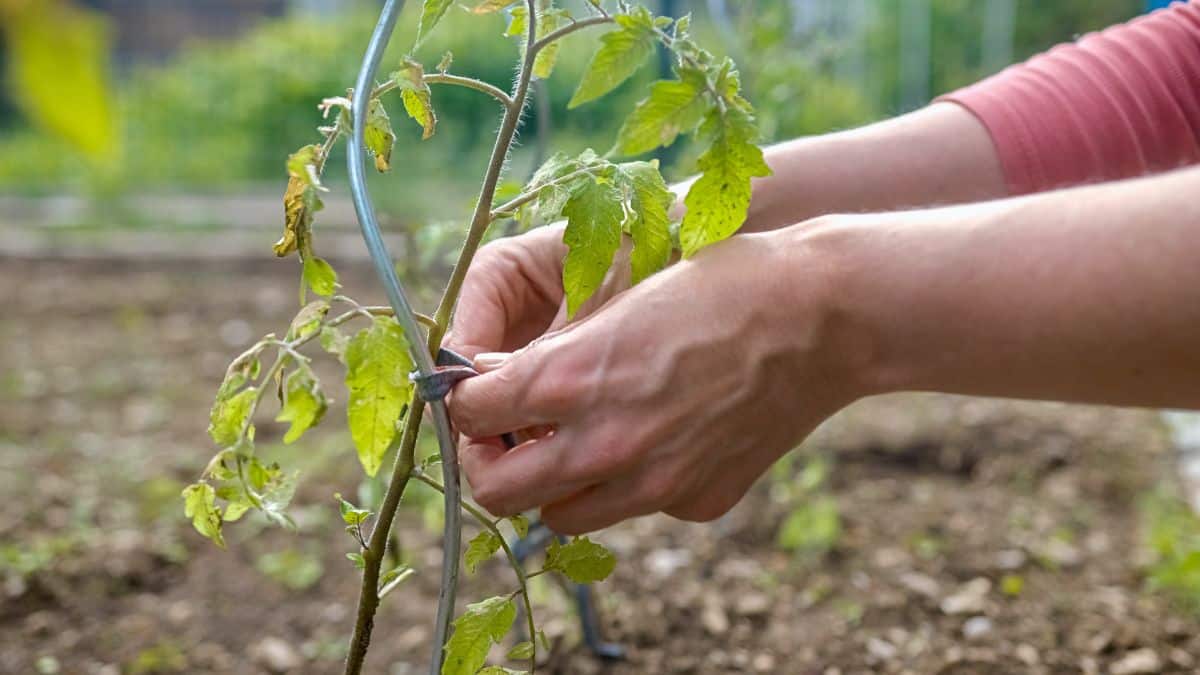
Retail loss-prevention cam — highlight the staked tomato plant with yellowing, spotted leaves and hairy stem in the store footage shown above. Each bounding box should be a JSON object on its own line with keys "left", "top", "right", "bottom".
{"left": 184, "top": 0, "right": 769, "bottom": 675}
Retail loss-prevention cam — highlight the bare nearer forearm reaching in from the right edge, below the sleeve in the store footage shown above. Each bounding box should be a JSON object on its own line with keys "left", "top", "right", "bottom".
{"left": 796, "top": 168, "right": 1200, "bottom": 407}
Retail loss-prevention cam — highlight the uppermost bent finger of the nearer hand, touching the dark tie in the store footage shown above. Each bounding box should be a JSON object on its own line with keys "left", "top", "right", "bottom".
{"left": 450, "top": 340, "right": 586, "bottom": 438}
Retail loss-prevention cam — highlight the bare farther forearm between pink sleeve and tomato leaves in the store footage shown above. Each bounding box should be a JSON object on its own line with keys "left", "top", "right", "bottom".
{"left": 724, "top": 103, "right": 1006, "bottom": 232}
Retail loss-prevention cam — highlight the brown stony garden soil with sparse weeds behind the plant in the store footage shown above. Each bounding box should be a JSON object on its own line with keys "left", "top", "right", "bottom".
{"left": 0, "top": 256, "right": 1200, "bottom": 675}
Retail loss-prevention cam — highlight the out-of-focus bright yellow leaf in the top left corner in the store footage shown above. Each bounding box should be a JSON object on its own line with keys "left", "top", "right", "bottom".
{"left": 0, "top": 0, "right": 118, "bottom": 160}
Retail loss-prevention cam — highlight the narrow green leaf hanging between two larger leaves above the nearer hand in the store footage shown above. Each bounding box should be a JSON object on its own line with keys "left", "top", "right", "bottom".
{"left": 620, "top": 162, "right": 674, "bottom": 285}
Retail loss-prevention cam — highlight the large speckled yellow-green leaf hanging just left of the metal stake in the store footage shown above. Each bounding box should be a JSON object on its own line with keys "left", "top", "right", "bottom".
{"left": 346, "top": 317, "right": 413, "bottom": 476}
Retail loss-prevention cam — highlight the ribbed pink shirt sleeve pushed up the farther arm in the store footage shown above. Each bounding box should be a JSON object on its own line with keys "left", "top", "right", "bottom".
{"left": 941, "top": 0, "right": 1200, "bottom": 195}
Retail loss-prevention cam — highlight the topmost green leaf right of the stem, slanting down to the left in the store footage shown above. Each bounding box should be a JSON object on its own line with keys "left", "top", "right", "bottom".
{"left": 566, "top": 7, "right": 655, "bottom": 108}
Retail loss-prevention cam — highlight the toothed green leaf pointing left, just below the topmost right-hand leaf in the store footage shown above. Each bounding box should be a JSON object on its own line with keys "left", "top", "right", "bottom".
{"left": 617, "top": 68, "right": 712, "bottom": 155}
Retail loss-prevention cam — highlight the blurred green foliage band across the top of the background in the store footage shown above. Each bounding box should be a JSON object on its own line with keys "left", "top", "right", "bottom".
{"left": 0, "top": 0, "right": 1141, "bottom": 196}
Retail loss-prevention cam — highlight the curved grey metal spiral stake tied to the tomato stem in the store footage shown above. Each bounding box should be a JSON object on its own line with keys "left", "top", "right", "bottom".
{"left": 346, "top": 0, "right": 462, "bottom": 675}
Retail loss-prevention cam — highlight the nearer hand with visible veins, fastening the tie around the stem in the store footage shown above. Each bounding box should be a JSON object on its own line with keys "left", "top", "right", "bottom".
{"left": 450, "top": 228, "right": 859, "bottom": 533}
